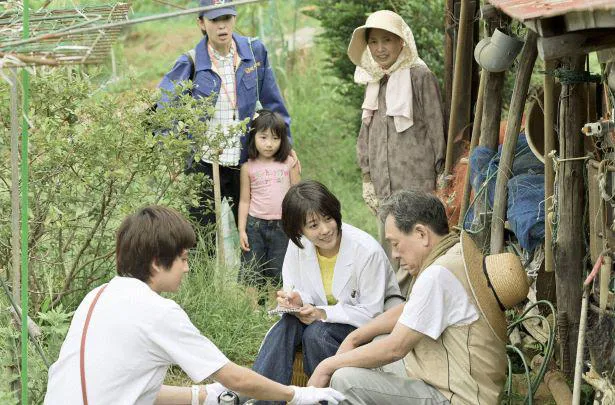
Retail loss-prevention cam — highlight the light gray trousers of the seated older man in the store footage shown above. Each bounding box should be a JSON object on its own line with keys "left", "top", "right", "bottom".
{"left": 331, "top": 361, "right": 450, "bottom": 405}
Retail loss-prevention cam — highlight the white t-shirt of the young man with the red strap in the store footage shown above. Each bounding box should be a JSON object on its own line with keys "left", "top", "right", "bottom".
{"left": 45, "top": 277, "right": 229, "bottom": 405}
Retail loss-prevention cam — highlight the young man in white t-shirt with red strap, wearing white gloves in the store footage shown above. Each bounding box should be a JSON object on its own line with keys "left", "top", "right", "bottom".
{"left": 45, "top": 206, "right": 343, "bottom": 405}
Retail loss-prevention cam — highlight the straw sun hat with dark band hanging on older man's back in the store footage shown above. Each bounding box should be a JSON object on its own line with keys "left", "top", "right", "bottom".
{"left": 461, "top": 232, "right": 529, "bottom": 342}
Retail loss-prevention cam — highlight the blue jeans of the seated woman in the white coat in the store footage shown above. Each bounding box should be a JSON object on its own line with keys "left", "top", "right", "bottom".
{"left": 252, "top": 314, "right": 356, "bottom": 405}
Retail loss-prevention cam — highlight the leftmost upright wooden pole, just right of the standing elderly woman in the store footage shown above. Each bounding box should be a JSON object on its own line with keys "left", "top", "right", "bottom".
{"left": 440, "top": 0, "right": 472, "bottom": 188}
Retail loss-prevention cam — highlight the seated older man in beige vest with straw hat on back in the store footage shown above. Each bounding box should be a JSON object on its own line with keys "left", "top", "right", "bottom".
{"left": 308, "top": 191, "right": 528, "bottom": 405}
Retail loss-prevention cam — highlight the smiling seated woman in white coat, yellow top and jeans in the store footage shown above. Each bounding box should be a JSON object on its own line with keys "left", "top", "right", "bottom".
{"left": 253, "top": 180, "right": 403, "bottom": 398}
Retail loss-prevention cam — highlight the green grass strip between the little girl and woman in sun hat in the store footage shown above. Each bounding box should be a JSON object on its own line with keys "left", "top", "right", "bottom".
{"left": 286, "top": 47, "right": 378, "bottom": 236}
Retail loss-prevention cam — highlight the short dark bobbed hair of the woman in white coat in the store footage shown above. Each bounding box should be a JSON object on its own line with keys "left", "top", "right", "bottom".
{"left": 282, "top": 180, "right": 342, "bottom": 249}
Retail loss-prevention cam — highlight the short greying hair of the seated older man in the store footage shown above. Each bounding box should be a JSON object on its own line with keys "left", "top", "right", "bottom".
{"left": 379, "top": 190, "right": 449, "bottom": 236}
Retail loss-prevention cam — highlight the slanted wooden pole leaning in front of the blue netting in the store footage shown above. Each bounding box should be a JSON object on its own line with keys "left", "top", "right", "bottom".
{"left": 491, "top": 30, "right": 538, "bottom": 254}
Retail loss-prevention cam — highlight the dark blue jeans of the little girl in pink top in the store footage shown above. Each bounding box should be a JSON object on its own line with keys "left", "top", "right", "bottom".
{"left": 239, "top": 215, "right": 288, "bottom": 287}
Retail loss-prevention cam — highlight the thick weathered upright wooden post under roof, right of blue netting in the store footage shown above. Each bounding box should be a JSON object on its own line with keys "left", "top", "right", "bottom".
{"left": 555, "top": 55, "right": 586, "bottom": 378}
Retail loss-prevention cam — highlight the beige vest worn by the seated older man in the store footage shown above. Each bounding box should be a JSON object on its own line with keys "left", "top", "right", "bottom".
{"left": 405, "top": 243, "right": 507, "bottom": 405}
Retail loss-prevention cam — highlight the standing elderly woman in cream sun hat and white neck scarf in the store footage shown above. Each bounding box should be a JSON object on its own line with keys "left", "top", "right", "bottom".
{"left": 348, "top": 10, "right": 446, "bottom": 294}
